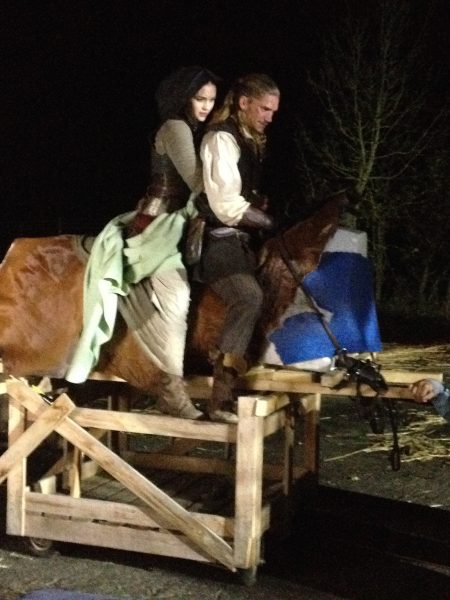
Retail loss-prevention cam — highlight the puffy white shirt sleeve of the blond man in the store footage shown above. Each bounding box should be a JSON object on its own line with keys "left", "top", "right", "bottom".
{"left": 200, "top": 131, "right": 250, "bottom": 226}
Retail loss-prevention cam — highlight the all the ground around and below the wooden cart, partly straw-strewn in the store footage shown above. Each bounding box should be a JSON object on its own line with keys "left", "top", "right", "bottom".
{"left": 0, "top": 344, "right": 450, "bottom": 600}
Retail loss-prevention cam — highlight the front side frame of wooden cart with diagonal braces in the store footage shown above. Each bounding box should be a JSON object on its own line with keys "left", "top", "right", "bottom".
{"left": 0, "top": 380, "right": 289, "bottom": 571}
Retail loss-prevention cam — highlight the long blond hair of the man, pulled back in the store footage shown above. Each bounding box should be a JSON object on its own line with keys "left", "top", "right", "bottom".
{"left": 211, "top": 73, "right": 280, "bottom": 123}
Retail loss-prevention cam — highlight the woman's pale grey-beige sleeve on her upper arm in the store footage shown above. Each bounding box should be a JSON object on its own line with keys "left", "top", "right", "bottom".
{"left": 155, "top": 119, "right": 203, "bottom": 193}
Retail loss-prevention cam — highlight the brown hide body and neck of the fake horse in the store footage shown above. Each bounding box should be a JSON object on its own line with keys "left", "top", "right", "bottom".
{"left": 0, "top": 195, "right": 345, "bottom": 392}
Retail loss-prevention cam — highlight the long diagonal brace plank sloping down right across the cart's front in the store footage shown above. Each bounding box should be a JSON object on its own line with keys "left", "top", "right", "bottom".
{"left": 8, "top": 382, "right": 236, "bottom": 571}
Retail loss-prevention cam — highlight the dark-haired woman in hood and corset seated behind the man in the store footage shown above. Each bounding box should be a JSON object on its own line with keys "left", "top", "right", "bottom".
{"left": 122, "top": 66, "right": 218, "bottom": 419}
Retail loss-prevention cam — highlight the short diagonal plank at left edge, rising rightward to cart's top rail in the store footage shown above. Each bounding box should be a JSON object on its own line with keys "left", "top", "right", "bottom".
{"left": 0, "top": 397, "right": 75, "bottom": 483}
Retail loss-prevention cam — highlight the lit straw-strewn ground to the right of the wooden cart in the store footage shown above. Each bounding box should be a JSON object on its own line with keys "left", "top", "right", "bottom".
{"left": 320, "top": 344, "right": 450, "bottom": 510}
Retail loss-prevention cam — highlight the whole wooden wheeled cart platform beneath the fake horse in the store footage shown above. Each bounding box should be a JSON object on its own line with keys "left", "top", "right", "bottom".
{"left": 0, "top": 369, "right": 442, "bottom": 578}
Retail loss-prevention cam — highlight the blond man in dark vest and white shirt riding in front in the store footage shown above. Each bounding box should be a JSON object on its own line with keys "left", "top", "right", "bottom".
{"left": 197, "top": 73, "right": 280, "bottom": 422}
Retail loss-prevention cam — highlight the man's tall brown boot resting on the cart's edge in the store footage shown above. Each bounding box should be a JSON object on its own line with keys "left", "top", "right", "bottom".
{"left": 209, "top": 353, "right": 246, "bottom": 423}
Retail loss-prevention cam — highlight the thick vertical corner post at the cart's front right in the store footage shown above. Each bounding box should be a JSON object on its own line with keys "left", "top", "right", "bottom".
{"left": 234, "top": 397, "right": 264, "bottom": 569}
